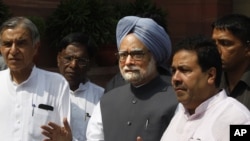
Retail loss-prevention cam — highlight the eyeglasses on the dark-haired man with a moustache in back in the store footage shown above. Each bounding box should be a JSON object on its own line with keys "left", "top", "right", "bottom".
{"left": 61, "top": 56, "right": 89, "bottom": 67}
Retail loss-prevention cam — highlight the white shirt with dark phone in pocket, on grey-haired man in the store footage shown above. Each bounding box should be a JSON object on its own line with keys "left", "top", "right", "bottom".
{"left": 0, "top": 67, "right": 70, "bottom": 141}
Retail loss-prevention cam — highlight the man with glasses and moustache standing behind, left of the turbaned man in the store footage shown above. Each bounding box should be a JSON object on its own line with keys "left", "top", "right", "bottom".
{"left": 41, "top": 33, "right": 104, "bottom": 141}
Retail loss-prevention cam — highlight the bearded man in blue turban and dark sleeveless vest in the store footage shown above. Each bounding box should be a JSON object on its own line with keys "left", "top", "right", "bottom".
{"left": 87, "top": 16, "right": 177, "bottom": 141}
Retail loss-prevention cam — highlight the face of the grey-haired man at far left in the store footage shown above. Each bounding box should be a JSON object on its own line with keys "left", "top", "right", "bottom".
{"left": 0, "top": 26, "right": 39, "bottom": 72}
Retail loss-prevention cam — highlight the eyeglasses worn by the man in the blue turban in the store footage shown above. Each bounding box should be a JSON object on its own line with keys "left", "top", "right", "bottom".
{"left": 115, "top": 50, "right": 148, "bottom": 62}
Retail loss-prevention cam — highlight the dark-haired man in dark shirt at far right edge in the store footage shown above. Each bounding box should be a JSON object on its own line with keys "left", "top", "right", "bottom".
{"left": 212, "top": 14, "right": 250, "bottom": 109}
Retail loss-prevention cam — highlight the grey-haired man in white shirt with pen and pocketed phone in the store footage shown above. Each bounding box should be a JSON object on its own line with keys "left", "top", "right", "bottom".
{"left": 0, "top": 17, "right": 70, "bottom": 141}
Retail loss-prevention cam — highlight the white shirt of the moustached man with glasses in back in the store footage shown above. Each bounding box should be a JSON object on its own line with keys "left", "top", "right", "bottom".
{"left": 70, "top": 81, "right": 104, "bottom": 141}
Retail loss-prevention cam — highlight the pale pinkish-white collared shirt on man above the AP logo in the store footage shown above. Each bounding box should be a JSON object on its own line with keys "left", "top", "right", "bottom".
{"left": 161, "top": 90, "right": 250, "bottom": 141}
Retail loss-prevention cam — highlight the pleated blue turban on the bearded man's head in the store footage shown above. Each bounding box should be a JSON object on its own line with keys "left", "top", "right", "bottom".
{"left": 116, "top": 16, "right": 171, "bottom": 68}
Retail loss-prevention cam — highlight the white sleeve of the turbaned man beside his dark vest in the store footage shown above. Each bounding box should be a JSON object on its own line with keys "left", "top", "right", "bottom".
{"left": 86, "top": 102, "right": 104, "bottom": 141}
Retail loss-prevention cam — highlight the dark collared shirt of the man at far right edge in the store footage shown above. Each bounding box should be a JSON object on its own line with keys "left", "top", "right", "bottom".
{"left": 221, "top": 67, "right": 250, "bottom": 110}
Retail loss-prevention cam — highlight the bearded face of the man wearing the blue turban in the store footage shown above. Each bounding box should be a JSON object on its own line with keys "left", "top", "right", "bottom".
{"left": 119, "top": 34, "right": 157, "bottom": 86}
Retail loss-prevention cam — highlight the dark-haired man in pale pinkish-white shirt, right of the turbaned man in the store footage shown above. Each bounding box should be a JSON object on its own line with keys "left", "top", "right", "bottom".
{"left": 161, "top": 36, "right": 250, "bottom": 141}
